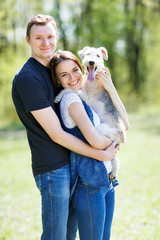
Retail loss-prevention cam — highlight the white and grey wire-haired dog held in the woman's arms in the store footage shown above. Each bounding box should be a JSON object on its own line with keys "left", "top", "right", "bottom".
{"left": 55, "top": 47, "right": 125, "bottom": 180}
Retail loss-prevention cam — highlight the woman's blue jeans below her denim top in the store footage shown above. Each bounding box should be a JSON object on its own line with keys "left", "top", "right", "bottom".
{"left": 72, "top": 180, "right": 115, "bottom": 240}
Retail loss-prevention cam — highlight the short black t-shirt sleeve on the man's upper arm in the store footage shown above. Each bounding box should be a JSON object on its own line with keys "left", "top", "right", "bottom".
{"left": 16, "top": 73, "right": 50, "bottom": 112}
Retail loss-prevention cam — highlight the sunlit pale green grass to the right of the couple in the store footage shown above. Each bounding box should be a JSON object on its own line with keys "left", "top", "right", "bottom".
{"left": 112, "top": 109, "right": 160, "bottom": 240}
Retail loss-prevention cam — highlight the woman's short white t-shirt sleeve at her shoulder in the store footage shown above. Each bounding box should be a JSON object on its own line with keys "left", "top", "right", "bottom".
{"left": 60, "top": 93, "right": 82, "bottom": 128}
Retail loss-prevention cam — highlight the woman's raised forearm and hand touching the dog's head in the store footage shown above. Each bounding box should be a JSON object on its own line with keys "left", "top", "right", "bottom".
{"left": 96, "top": 68, "right": 129, "bottom": 130}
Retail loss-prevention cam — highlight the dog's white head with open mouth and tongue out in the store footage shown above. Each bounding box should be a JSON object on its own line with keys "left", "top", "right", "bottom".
{"left": 78, "top": 47, "right": 108, "bottom": 81}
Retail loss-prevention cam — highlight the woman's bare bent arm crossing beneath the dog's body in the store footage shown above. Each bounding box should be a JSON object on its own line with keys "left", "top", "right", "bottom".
{"left": 68, "top": 102, "right": 112, "bottom": 149}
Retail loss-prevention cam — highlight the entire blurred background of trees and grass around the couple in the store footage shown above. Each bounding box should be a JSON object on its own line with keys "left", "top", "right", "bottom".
{"left": 0, "top": 0, "right": 160, "bottom": 240}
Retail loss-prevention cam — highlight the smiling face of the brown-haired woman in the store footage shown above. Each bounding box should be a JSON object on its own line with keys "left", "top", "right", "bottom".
{"left": 56, "top": 60, "right": 83, "bottom": 90}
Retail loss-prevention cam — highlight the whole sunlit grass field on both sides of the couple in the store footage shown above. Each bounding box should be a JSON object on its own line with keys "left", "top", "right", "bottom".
{"left": 0, "top": 109, "right": 160, "bottom": 240}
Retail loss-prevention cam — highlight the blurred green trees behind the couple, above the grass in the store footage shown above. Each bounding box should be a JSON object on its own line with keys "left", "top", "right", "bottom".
{"left": 0, "top": 0, "right": 160, "bottom": 124}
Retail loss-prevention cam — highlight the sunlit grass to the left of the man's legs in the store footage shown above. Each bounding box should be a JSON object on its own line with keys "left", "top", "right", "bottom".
{"left": 0, "top": 131, "right": 41, "bottom": 240}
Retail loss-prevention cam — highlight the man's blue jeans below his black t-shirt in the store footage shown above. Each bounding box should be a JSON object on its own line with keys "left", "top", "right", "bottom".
{"left": 35, "top": 165, "right": 74, "bottom": 240}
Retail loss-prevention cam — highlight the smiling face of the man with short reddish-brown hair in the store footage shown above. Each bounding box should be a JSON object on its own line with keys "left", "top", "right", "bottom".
{"left": 26, "top": 23, "right": 57, "bottom": 66}
